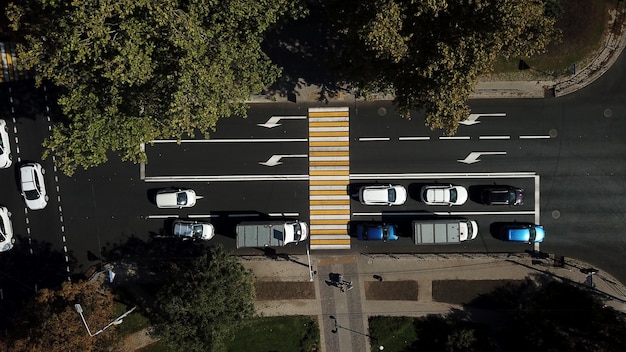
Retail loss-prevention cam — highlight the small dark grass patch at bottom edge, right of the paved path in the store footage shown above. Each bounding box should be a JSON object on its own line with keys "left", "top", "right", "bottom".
{"left": 369, "top": 316, "right": 417, "bottom": 351}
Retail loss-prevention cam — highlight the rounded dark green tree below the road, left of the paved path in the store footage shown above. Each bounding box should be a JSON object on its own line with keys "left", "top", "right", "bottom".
{"left": 155, "top": 247, "right": 254, "bottom": 352}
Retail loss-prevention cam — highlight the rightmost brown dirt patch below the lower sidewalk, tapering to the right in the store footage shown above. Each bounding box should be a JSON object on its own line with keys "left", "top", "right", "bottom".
{"left": 433, "top": 280, "right": 524, "bottom": 304}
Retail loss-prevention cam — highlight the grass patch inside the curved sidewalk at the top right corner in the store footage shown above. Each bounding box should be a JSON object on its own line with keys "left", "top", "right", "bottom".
{"left": 494, "top": 0, "right": 615, "bottom": 79}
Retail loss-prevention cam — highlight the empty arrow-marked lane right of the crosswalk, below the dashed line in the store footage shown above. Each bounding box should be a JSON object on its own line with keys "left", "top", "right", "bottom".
{"left": 350, "top": 139, "right": 559, "bottom": 174}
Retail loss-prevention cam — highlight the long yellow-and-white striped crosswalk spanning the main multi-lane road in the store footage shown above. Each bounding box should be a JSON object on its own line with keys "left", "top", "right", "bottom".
{"left": 308, "top": 107, "right": 350, "bottom": 250}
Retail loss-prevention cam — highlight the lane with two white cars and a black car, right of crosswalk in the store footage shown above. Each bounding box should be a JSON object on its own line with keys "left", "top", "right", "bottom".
{"left": 349, "top": 174, "right": 536, "bottom": 213}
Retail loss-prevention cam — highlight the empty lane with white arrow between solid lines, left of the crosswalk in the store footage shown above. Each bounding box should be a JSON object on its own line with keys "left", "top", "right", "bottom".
{"left": 145, "top": 139, "right": 309, "bottom": 176}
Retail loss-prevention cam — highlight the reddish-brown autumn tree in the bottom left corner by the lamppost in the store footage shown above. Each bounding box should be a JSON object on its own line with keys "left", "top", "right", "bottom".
{"left": 0, "top": 282, "right": 115, "bottom": 352}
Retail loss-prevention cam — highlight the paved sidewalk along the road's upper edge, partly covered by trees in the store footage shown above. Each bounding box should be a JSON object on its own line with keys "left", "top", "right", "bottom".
{"left": 248, "top": 1, "right": 626, "bottom": 104}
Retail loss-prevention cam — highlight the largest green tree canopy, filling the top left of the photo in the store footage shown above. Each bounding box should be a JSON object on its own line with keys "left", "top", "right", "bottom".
{"left": 7, "top": 0, "right": 304, "bottom": 175}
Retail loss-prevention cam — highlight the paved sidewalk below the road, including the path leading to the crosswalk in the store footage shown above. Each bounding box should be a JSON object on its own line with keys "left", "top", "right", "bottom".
{"left": 242, "top": 253, "right": 626, "bottom": 352}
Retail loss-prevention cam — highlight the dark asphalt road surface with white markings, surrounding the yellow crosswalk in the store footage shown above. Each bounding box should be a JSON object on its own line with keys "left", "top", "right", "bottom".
{"left": 0, "top": 48, "right": 626, "bottom": 298}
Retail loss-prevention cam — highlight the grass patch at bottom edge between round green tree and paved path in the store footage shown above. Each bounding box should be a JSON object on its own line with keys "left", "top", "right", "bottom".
{"left": 227, "top": 316, "right": 320, "bottom": 352}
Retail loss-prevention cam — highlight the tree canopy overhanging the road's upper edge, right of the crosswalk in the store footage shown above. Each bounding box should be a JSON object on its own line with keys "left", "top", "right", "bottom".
{"left": 326, "top": 0, "right": 559, "bottom": 134}
